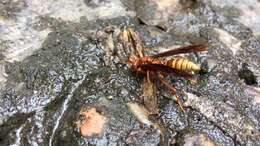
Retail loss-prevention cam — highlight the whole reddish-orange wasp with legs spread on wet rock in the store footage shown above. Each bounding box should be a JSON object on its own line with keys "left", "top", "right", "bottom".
{"left": 123, "top": 28, "right": 208, "bottom": 112}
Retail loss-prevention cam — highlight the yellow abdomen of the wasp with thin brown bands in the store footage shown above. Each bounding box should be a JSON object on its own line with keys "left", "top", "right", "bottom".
{"left": 167, "top": 58, "right": 201, "bottom": 72}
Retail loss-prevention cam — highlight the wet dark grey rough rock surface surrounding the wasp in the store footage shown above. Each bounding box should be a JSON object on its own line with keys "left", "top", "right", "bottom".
{"left": 0, "top": 0, "right": 260, "bottom": 146}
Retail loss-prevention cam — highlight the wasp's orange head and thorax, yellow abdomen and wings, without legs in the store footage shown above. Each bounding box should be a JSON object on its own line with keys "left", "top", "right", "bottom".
{"left": 129, "top": 44, "right": 207, "bottom": 76}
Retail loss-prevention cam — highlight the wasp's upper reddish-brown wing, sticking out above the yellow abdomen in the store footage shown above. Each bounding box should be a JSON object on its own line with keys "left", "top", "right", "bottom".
{"left": 151, "top": 44, "right": 208, "bottom": 58}
